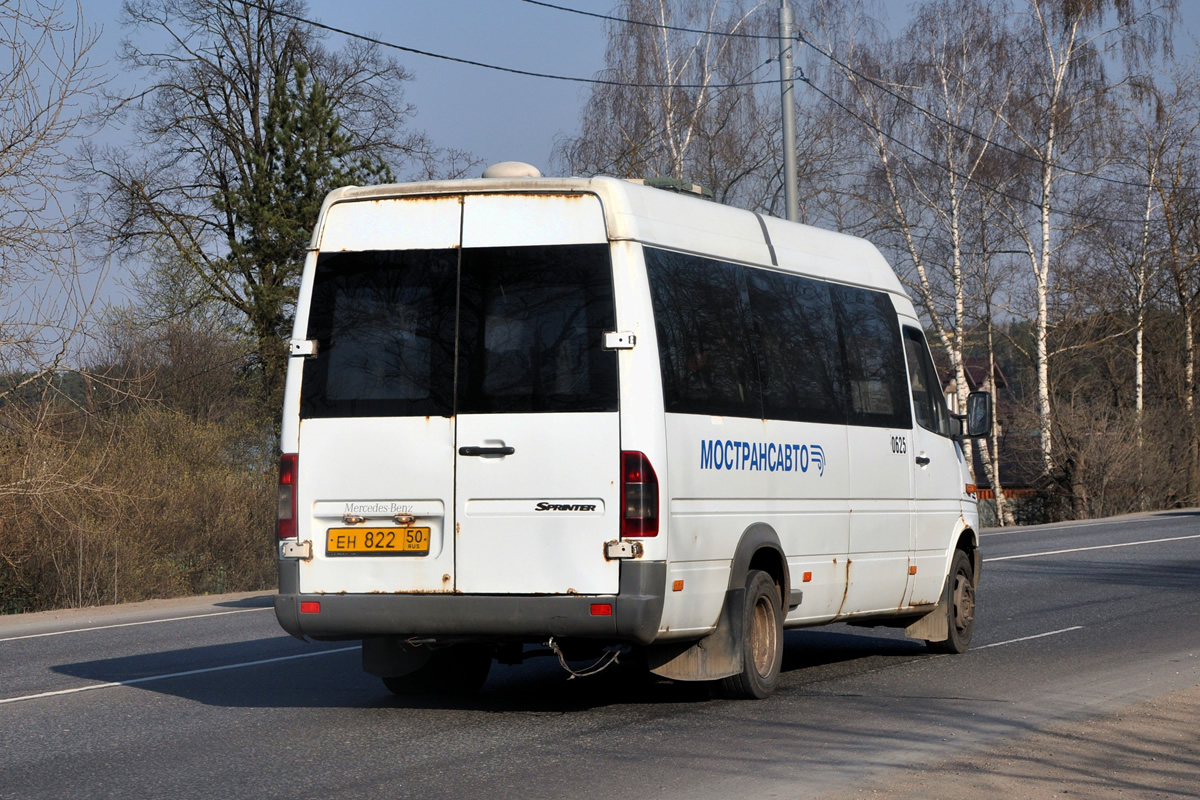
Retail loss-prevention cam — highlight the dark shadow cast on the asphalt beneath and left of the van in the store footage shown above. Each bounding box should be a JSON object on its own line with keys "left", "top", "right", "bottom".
{"left": 44, "top": 631, "right": 924, "bottom": 714}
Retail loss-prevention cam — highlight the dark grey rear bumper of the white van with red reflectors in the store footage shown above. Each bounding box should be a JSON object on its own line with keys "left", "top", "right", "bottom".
{"left": 275, "top": 559, "right": 667, "bottom": 644}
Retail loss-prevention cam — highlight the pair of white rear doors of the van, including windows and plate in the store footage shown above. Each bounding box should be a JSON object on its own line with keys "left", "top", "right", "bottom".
{"left": 298, "top": 196, "right": 620, "bottom": 594}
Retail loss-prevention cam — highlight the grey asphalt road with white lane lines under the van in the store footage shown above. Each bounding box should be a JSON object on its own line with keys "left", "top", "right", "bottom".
{"left": 0, "top": 511, "right": 1200, "bottom": 800}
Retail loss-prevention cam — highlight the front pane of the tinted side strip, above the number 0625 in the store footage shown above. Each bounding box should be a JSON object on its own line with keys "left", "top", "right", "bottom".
{"left": 832, "top": 284, "right": 912, "bottom": 428}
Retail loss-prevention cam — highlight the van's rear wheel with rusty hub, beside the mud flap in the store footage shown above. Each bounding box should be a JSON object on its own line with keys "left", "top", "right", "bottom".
{"left": 721, "top": 570, "right": 784, "bottom": 699}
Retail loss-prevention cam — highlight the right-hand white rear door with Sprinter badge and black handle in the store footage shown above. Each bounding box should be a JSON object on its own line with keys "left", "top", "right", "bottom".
{"left": 455, "top": 196, "right": 620, "bottom": 594}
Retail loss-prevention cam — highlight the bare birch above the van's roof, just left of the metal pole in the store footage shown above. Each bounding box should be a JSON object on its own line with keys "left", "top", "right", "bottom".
{"left": 556, "top": 0, "right": 781, "bottom": 207}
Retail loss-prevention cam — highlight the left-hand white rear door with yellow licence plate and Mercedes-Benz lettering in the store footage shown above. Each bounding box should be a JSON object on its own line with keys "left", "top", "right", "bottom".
{"left": 296, "top": 197, "right": 462, "bottom": 593}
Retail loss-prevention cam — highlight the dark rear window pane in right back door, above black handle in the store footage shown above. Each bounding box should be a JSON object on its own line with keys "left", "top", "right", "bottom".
{"left": 458, "top": 245, "right": 617, "bottom": 414}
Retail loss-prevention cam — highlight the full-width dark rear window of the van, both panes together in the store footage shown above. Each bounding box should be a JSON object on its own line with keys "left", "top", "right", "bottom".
{"left": 300, "top": 245, "right": 617, "bottom": 417}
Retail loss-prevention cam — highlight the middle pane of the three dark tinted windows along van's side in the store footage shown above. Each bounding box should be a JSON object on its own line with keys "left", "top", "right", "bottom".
{"left": 746, "top": 270, "right": 846, "bottom": 423}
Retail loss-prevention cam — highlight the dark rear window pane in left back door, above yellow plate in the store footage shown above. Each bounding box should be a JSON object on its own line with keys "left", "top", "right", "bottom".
{"left": 300, "top": 251, "right": 458, "bottom": 416}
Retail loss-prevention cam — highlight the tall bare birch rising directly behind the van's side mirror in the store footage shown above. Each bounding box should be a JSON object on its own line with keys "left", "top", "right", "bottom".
{"left": 833, "top": 0, "right": 1012, "bottom": 522}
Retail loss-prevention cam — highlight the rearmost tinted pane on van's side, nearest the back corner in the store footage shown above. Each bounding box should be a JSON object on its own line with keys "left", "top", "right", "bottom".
{"left": 644, "top": 247, "right": 763, "bottom": 419}
